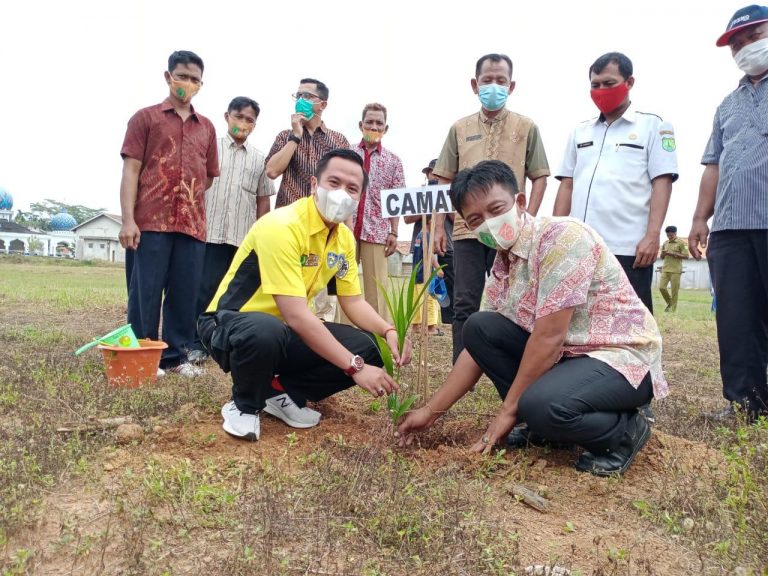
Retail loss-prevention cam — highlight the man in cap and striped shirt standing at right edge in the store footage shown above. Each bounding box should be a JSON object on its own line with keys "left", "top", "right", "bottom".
{"left": 688, "top": 5, "right": 768, "bottom": 420}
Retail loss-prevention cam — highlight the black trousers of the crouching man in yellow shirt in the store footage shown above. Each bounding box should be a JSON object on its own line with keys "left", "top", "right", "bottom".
{"left": 197, "top": 310, "right": 383, "bottom": 414}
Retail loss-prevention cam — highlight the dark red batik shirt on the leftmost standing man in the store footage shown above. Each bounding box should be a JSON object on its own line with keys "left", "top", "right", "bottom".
{"left": 120, "top": 99, "right": 219, "bottom": 242}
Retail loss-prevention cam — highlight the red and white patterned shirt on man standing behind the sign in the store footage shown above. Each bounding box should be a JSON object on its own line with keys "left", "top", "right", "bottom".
{"left": 352, "top": 142, "right": 405, "bottom": 244}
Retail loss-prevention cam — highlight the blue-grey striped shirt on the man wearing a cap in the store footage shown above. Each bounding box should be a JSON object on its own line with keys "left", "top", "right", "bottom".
{"left": 701, "top": 76, "right": 768, "bottom": 232}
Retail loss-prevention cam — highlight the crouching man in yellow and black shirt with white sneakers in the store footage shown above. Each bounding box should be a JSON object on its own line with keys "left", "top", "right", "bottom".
{"left": 198, "top": 149, "right": 411, "bottom": 440}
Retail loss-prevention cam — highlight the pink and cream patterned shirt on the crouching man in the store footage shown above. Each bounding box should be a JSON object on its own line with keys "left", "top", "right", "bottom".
{"left": 482, "top": 215, "right": 669, "bottom": 399}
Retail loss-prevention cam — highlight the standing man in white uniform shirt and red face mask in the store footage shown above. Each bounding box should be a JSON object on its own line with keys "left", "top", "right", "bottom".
{"left": 553, "top": 52, "right": 678, "bottom": 312}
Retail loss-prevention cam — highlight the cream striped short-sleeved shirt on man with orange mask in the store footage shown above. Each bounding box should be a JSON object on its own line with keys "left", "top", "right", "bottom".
{"left": 205, "top": 133, "right": 275, "bottom": 246}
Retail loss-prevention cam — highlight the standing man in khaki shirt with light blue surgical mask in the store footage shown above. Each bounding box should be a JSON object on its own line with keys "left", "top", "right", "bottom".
{"left": 433, "top": 54, "right": 549, "bottom": 362}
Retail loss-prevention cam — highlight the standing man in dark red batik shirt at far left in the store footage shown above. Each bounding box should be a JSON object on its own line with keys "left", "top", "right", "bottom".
{"left": 119, "top": 50, "right": 219, "bottom": 376}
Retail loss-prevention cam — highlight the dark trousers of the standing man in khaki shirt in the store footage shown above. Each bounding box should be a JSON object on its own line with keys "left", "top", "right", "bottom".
{"left": 453, "top": 239, "right": 496, "bottom": 362}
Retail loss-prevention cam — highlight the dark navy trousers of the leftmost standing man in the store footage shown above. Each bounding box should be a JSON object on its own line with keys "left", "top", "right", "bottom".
{"left": 125, "top": 232, "right": 205, "bottom": 369}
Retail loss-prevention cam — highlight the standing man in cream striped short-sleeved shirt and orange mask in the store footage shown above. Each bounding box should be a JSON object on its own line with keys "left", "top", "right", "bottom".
{"left": 188, "top": 96, "right": 275, "bottom": 364}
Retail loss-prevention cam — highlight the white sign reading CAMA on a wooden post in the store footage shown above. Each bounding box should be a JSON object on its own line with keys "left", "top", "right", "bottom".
{"left": 381, "top": 184, "right": 453, "bottom": 405}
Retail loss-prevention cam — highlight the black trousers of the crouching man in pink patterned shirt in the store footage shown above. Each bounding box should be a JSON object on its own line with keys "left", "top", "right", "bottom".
{"left": 464, "top": 312, "right": 653, "bottom": 454}
